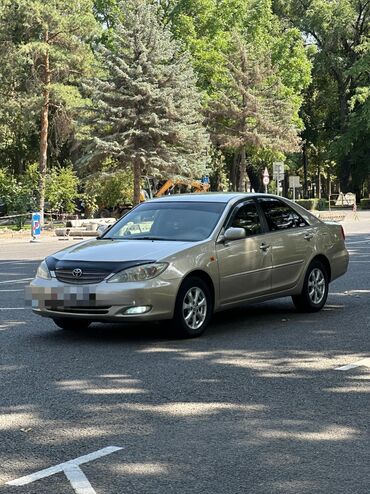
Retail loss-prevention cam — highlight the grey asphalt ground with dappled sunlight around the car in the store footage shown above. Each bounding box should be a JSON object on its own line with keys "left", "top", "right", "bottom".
{"left": 0, "top": 225, "right": 370, "bottom": 494}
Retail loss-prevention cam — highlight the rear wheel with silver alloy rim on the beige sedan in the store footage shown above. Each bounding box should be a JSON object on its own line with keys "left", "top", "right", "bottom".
{"left": 292, "top": 260, "right": 329, "bottom": 312}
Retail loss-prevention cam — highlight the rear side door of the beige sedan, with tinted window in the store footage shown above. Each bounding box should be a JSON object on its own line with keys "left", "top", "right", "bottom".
{"left": 258, "top": 197, "right": 315, "bottom": 292}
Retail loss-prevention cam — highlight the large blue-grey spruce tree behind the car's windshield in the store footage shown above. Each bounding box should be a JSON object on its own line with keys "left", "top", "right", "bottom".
{"left": 82, "top": 0, "right": 209, "bottom": 204}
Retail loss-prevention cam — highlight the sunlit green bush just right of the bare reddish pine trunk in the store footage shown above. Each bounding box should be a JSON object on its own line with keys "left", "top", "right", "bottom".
{"left": 45, "top": 165, "right": 79, "bottom": 213}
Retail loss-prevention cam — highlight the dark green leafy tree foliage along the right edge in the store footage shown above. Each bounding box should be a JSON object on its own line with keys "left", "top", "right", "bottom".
{"left": 275, "top": 0, "right": 370, "bottom": 192}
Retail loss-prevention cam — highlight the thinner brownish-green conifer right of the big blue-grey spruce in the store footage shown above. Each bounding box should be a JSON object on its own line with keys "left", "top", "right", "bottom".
{"left": 207, "top": 38, "right": 299, "bottom": 191}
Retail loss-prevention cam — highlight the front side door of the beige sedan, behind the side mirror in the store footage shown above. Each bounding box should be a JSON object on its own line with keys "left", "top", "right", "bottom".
{"left": 216, "top": 199, "right": 272, "bottom": 305}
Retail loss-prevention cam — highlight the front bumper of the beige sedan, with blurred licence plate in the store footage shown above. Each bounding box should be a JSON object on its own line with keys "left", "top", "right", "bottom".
{"left": 26, "top": 277, "right": 181, "bottom": 322}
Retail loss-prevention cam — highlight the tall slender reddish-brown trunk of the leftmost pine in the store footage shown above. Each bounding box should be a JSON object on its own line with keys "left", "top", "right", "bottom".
{"left": 39, "top": 31, "right": 50, "bottom": 224}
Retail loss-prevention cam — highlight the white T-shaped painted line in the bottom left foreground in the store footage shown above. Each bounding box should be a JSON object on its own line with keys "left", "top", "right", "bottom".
{"left": 7, "top": 446, "right": 123, "bottom": 494}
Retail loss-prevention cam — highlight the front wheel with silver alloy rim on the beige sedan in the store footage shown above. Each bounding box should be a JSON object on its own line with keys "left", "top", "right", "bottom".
{"left": 172, "top": 276, "right": 213, "bottom": 338}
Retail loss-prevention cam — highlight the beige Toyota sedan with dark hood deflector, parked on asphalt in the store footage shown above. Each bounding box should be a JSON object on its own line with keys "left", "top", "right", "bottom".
{"left": 30, "top": 192, "right": 349, "bottom": 338}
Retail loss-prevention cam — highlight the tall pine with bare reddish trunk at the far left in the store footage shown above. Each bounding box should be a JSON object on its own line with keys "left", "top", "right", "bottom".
{"left": 0, "top": 0, "right": 98, "bottom": 220}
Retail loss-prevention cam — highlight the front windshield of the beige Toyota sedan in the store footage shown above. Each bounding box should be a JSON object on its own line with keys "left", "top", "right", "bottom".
{"left": 102, "top": 202, "right": 225, "bottom": 242}
